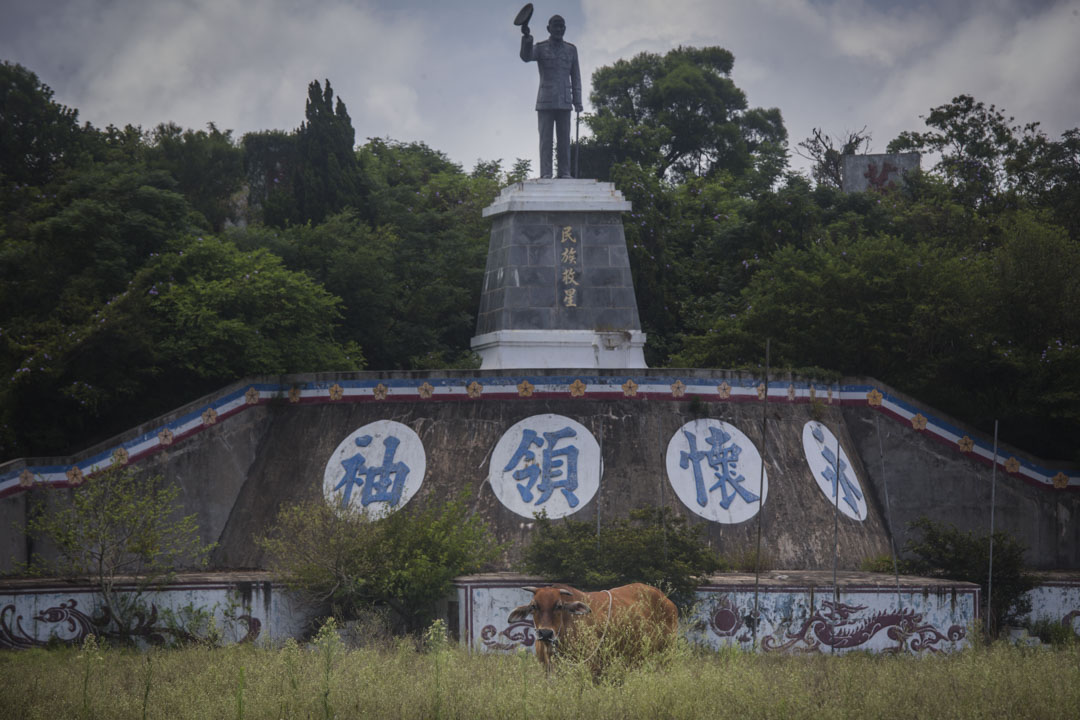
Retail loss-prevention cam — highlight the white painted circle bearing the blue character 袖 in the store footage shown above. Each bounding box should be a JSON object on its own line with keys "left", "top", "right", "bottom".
{"left": 323, "top": 420, "right": 428, "bottom": 518}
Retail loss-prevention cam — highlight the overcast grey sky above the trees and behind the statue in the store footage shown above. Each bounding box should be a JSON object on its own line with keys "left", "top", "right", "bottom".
{"left": 0, "top": 0, "right": 1080, "bottom": 172}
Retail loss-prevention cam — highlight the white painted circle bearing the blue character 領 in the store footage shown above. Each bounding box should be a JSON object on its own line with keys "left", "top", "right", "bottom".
{"left": 488, "top": 413, "right": 604, "bottom": 519}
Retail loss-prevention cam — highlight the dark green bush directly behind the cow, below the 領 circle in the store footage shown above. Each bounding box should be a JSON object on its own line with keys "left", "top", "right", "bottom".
{"left": 524, "top": 507, "right": 721, "bottom": 607}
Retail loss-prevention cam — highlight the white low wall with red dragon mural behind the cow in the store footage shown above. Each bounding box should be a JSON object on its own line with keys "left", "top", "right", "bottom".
{"left": 458, "top": 581, "right": 978, "bottom": 653}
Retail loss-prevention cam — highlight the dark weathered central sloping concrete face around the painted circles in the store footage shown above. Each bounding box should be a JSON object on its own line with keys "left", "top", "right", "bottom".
{"left": 214, "top": 398, "right": 889, "bottom": 568}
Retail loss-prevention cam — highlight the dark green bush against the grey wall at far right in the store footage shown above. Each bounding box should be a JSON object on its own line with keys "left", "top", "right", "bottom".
{"left": 900, "top": 517, "right": 1035, "bottom": 634}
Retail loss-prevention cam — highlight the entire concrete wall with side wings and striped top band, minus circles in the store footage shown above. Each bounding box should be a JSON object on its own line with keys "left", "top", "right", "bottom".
{"left": 0, "top": 369, "right": 1080, "bottom": 569}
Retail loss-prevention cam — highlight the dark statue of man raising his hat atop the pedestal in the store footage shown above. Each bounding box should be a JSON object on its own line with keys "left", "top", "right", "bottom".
{"left": 522, "top": 15, "right": 581, "bottom": 178}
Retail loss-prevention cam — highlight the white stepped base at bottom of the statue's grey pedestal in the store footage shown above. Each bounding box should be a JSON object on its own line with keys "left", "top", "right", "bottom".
{"left": 471, "top": 330, "right": 647, "bottom": 370}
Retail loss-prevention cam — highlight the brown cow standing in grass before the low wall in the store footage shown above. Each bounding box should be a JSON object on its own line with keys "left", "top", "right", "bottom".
{"left": 509, "top": 583, "right": 678, "bottom": 669}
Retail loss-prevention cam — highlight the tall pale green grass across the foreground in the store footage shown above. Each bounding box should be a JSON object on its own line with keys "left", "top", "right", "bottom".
{"left": 0, "top": 642, "right": 1080, "bottom": 720}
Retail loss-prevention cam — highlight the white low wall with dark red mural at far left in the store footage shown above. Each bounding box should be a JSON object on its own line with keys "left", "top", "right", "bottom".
{"left": 0, "top": 579, "right": 310, "bottom": 650}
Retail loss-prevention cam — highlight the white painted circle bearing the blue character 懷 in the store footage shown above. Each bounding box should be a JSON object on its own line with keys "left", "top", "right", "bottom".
{"left": 666, "top": 418, "right": 769, "bottom": 525}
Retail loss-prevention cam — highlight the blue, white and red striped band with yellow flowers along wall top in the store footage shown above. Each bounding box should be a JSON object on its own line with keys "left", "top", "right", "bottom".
{"left": 0, "top": 373, "right": 1080, "bottom": 498}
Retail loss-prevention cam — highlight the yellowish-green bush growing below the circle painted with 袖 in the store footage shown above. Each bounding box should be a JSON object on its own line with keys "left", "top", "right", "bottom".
{"left": 258, "top": 498, "right": 502, "bottom": 630}
